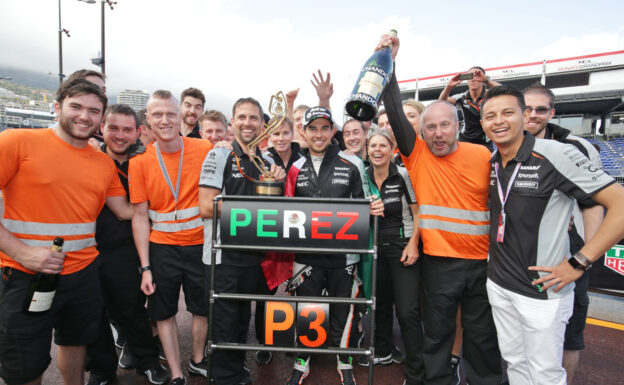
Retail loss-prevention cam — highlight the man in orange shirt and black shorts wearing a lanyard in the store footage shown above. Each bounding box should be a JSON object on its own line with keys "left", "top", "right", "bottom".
{"left": 129, "top": 90, "right": 212, "bottom": 385}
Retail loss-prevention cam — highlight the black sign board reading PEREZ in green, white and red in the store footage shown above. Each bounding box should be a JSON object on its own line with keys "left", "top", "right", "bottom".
{"left": 220, "top": 196, "right": 370, "bottom": 253}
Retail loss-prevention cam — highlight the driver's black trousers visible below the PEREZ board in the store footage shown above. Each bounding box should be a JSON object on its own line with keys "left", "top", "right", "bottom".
{"left": 293, "top": 263, "right": 357, "bottom": 364}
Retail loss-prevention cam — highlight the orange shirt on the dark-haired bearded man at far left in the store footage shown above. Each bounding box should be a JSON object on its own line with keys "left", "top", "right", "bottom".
{"left": 0, "top": 128, "right": 126, "bottom": 274}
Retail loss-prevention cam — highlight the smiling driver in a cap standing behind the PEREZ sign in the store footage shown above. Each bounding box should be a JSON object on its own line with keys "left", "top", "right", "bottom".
{"left": 285, "top": 106, "right": 383, "bottom": 385}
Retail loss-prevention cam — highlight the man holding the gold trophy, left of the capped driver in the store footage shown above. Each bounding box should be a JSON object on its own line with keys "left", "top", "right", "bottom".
{"left": 199, "top": 98, "right": 285, "bottom": 385}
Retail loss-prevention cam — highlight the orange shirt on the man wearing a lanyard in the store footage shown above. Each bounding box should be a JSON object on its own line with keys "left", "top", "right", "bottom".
{"left": 128, "top": 137, "right": 212, "bottom": 246}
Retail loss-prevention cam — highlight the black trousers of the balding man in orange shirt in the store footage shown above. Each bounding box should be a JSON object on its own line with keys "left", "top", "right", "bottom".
{"left": 422, "top": 255, "right": 502, "bottom": 385}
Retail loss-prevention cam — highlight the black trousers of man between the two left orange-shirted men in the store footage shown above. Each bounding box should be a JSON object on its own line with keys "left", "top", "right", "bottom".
{"left": 87, "top": 245, "right": 158, "bottom": 373}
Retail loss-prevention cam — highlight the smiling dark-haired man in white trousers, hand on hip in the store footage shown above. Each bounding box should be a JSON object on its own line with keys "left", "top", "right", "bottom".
{"left": 480, "top": 86, "right": 624, "bottom": 385}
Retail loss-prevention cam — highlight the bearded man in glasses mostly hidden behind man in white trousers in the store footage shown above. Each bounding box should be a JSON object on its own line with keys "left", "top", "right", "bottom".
{"left": 523, "top": 83, "right": 604, "bottom": 384}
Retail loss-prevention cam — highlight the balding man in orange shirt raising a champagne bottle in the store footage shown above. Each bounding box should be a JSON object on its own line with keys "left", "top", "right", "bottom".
{"left": 377, "top": 35, "right": 501, "bottom": 385}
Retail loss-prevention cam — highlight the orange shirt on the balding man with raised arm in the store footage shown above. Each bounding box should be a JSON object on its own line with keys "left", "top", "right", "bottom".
{"left": 402, "top": 137, "right": 490, "bottom": 259}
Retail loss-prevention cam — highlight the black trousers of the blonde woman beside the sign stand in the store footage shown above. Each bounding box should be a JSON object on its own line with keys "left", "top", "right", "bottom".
{"left": 375, "top": 241, "right": 425, "bottom": 384}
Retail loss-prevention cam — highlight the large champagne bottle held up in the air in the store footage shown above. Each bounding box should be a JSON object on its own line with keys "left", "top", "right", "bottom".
{"left": 345, "top": 29, "right": 397, "bottom": 121}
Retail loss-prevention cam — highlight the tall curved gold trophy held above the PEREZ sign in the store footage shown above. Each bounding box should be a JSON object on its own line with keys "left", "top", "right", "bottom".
{"left": 247, "top": 91, "right": 288, "bottom": 196}
